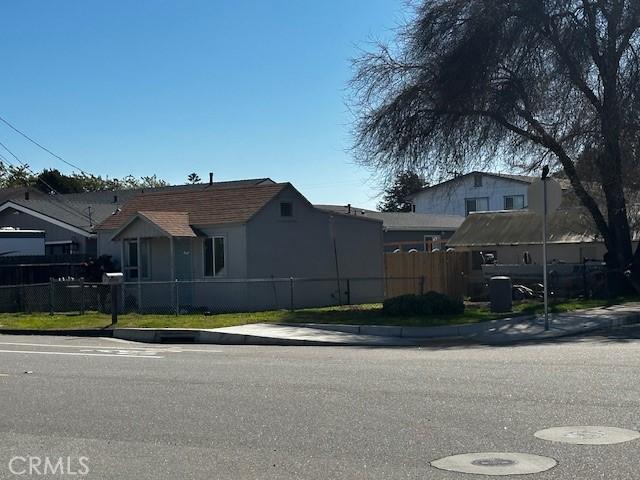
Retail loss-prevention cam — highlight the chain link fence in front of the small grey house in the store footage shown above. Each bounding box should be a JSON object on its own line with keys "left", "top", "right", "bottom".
{"left": 0, "top": 277, "right": 436, "bottom": 315}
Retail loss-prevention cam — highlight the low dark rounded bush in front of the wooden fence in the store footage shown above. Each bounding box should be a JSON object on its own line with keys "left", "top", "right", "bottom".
{"left": 382, "top": 292, "right": 464, "bottom": 316}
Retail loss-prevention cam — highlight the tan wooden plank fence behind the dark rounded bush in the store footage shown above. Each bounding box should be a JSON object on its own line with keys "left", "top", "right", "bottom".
{"left": 384, "top": 252, "right": 471, "bottom": 298}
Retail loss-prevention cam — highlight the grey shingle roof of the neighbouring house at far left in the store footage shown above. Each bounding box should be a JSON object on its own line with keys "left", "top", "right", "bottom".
{"left": 0, "top": 178, "right": 275, "bottom": 234}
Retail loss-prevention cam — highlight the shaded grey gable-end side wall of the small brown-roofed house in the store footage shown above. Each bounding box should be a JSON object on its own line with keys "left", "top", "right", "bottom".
{"left": 247, "top": 191, "right": 384, "bottom": 306}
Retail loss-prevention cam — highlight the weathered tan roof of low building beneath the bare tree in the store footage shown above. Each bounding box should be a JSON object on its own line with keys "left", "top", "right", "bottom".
{"left": 447, "top": 207, "right": 601, "bottom": 247}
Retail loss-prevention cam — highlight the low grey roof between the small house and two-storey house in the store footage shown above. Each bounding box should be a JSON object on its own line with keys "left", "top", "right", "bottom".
{"left": 314, "top": 205, "right": 464, "bottom": 231}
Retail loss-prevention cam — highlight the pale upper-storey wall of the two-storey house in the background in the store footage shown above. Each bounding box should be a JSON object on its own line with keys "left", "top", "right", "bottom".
{"left": 413, "top": 175, "right": 528, "bottom": 216}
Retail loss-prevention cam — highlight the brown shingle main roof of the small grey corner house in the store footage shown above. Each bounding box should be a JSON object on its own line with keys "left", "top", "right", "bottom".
{"left": 97, "top": 183, "right": 288, "bottom": 230}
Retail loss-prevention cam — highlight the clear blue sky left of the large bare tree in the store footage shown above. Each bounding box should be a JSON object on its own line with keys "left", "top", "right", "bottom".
{"left": 0, "top": 0, "right": 405, "bottom": 207}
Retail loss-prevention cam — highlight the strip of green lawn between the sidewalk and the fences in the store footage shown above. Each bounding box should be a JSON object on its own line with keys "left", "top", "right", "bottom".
{"left": 0, "top": 298, "right": 638, "bottom": 330}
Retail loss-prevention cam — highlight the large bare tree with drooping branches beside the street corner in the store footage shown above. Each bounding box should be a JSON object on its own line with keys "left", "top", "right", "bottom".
{"left": 352, "top": 0, "right": 640, "bottom": 285}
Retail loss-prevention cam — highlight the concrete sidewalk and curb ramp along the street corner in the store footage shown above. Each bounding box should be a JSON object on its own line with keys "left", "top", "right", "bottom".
{"left": 113, "top": 303, "right": 640, "bottom": 346}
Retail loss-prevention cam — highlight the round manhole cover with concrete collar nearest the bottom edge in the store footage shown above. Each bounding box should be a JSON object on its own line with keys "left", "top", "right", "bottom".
{"left": 431, "top": 452, "right": 558, "bottom": 476}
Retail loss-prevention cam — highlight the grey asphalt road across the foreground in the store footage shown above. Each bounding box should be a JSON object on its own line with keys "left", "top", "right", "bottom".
{"left": 0, "top": 328, "right": 640, "bottom": 480}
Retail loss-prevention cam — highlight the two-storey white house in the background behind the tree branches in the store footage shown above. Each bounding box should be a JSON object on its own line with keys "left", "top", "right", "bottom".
{"left": 410, "top": 172, "right": 536, "bottom": 216}
